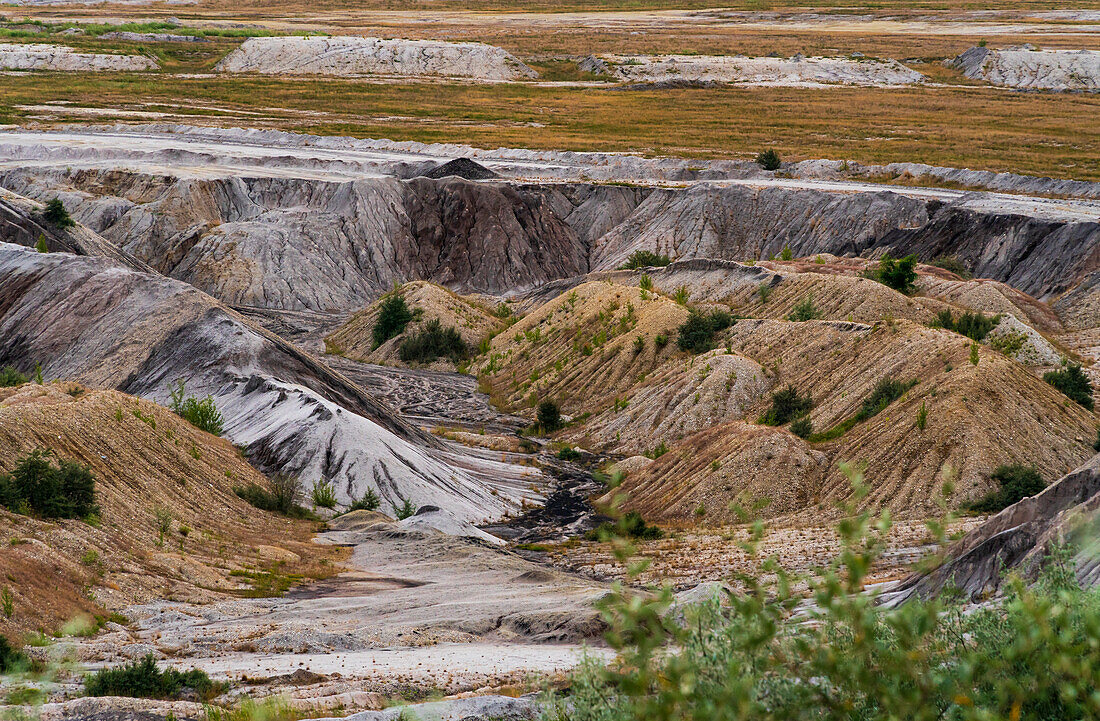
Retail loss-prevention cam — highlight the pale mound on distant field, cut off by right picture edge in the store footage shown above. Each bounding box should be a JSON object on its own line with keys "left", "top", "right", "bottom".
{"left": 949, "top": 45, "right": 1100, "bottom": 91}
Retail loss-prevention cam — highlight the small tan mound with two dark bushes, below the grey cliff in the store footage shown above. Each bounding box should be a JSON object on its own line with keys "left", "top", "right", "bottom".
{"left": 325, "top": 281, "right": 504, "bottom": 368}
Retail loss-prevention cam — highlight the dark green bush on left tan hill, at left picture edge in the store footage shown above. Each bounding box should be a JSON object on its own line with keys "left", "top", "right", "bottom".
{"left": 0, "top": 450, "right": 99, "bottom": 518}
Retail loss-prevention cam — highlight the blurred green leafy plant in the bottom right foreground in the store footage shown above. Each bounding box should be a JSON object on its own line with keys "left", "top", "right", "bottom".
{"left": 546, "top": 467, "right": 1100, "bottom": 721}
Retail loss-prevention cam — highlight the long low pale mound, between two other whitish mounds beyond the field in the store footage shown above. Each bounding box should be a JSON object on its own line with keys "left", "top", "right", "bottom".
{"left": 606, "top": 55, "right": 924, "bottom": 87}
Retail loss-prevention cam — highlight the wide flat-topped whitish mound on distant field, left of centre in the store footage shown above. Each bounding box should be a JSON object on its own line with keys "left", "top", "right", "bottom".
{"left": 216, "top": 36, "right": 537, "bottom": 80}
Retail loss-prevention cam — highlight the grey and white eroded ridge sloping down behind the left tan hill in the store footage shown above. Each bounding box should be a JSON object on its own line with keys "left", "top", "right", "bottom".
{"left": 0, "top": 244, "right": 534, "bottom": 520}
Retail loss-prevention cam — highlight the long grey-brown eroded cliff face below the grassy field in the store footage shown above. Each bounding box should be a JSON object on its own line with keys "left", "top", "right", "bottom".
{"left": 0, "top": 167, "right": 1100, "bottom": 312}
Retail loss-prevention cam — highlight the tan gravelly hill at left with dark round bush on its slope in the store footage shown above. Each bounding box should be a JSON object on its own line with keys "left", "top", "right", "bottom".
{"left": 0, "top": 382, "right": 340, "bottom": 635}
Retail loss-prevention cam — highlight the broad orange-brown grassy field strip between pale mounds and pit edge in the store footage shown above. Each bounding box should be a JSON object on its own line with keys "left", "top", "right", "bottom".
{"left": 0, "top": 74, "right": 1100, "bottom": 181}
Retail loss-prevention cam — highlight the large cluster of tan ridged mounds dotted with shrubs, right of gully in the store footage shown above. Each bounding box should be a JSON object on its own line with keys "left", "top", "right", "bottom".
{"left": 476, "top": 256, "right": 1098, "bottom": 522}
